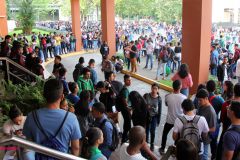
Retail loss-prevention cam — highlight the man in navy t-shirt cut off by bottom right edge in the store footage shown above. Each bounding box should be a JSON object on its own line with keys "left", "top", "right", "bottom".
{"left": 223, "top": 101, "right": 240, "bottom": 160}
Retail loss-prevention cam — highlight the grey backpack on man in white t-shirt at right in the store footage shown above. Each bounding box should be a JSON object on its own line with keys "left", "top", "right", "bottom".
{"left": 179, "top": 115, "right": 201, "bottom": 152}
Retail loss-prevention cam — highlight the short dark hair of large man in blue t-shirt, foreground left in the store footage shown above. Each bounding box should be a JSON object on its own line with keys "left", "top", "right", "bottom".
{"left": 43, "top": 79, "right": 63, "bottom": 103}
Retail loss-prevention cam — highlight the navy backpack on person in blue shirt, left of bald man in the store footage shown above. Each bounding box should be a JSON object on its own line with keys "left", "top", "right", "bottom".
{"left": 99, "top": 119, "right": 120, "bottom": 151}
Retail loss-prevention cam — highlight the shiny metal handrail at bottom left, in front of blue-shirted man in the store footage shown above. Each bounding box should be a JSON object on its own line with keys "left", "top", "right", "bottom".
{"left": 0, "top": 136, "right": 85, "bottom": 160}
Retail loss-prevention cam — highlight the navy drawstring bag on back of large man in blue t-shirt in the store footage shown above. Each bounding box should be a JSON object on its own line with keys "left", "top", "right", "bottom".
{"left": 32, "top": 111, "right": 69, "bottom": 160}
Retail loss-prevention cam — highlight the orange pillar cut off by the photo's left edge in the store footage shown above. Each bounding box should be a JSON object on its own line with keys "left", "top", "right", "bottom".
{"left": 0, "top": 0, "right": 8, "bottom": 38}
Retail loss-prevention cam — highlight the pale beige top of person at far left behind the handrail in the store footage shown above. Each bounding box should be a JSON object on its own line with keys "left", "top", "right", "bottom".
{"left": 3, "top": 116, "right": 26, "bottom": 134}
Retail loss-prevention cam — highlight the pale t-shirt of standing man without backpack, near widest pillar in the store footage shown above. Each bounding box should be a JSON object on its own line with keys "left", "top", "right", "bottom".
{"left": 165, "top": 93, "right": 187, "bottom": 124}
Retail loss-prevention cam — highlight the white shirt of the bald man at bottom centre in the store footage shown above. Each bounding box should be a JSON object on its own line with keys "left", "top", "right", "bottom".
{"left": 119, "top": 143, "right": 147, "bottom": 160}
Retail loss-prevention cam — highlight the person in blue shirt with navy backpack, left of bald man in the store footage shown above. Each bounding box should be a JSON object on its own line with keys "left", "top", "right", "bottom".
{"left": 92, "top": 102, "right": 119, "bottom": 158}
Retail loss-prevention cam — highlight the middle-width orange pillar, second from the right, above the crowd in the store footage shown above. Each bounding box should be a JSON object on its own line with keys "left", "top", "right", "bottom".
{"left": 101, "top": 0, "right": 116, "bottom": 57}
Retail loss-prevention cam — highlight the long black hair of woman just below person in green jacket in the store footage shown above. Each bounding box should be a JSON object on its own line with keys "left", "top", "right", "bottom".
{"left": 74, "top": 90, "right": 90, "bottom": 117}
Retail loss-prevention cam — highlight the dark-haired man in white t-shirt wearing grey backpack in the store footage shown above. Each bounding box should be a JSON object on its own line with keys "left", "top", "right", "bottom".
{"left": 173, "top": 99, "right": 209, "bottom": 157}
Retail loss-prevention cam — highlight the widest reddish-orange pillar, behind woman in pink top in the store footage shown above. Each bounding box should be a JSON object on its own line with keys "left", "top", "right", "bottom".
{"left": 182, "top": 0, "right": 212, "bottom": 93}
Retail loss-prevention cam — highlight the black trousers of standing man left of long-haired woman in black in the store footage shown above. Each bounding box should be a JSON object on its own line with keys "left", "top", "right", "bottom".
{"left": 121, "top": 109, "right": 131, "bottom": 143}
